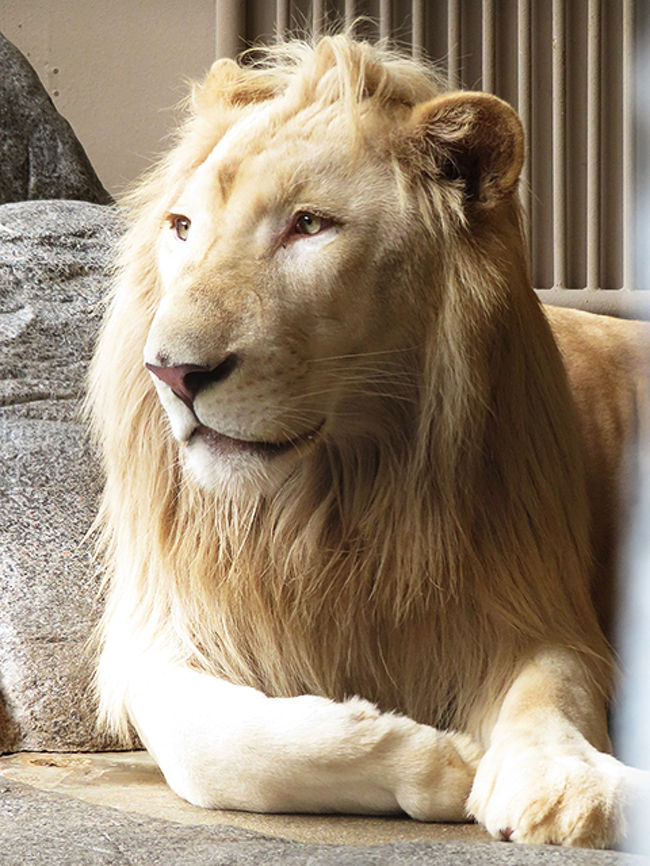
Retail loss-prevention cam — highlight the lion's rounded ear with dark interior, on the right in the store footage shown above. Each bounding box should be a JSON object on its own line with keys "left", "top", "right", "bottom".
{"left": 408, "top": 91, "right": 524, "bottom": 205}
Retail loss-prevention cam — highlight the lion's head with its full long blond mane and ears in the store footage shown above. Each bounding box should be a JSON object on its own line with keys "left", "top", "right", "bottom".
{"left": 91, "top": 36, "right": 604, "bottom": 736}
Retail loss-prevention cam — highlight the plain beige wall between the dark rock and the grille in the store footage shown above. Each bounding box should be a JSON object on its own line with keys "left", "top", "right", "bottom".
{"left": 0, "top": 0, "right": 215, "bottom": 195}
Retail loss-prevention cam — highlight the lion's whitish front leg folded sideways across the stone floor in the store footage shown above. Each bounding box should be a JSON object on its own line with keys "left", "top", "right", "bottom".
{"left": 129, "top": 658, "right": 479, "bottom": 821}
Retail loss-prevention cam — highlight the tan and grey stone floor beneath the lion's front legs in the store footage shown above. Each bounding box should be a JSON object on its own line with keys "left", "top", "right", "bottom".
{"left": 0, "top": 752, "right": 648, "bottom": 866}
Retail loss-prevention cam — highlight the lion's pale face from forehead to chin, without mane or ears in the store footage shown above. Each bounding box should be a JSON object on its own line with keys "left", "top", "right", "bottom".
{"left": 144, "top": 100, "right": 417, "bottom": 489}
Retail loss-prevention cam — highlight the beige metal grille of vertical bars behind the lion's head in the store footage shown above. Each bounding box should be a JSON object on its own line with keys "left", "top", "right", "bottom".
{"left": 216, "top": 0, "right": 650, "bottom": 303}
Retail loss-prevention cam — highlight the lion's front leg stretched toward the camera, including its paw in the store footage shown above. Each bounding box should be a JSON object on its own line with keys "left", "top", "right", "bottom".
{"left": 468, "top": 650, "right": 646, "bottom": 848}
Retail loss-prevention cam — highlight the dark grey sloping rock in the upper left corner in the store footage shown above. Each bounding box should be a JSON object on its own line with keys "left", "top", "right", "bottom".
{"left": 0, "top": 34, "right": 111, "bottom": 204}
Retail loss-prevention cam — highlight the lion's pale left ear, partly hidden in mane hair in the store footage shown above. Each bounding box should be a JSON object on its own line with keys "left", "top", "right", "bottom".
{"left": 192, "top": 57, "right": 280, "bottom": 114}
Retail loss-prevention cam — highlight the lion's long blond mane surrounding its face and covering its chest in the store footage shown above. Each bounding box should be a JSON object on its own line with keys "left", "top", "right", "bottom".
{"left": 90, "top": 36, "right": 607, "bottom": 739}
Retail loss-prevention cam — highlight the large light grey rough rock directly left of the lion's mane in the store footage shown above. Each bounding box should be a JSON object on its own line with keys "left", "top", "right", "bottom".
{"left": 0, "top": 201, "right": 119, "bottom": 751}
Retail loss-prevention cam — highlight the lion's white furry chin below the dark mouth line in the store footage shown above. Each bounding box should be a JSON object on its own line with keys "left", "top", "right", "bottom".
{"left": 184, "top": 423, "right": 323, "bottom": 499}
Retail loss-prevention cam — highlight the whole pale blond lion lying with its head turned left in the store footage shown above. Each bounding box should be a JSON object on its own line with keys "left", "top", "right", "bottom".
{"left": 89, "top": 35, "right": 648, "bottom": 847}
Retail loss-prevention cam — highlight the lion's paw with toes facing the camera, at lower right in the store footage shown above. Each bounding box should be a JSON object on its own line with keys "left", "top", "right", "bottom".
{"left": 468, "top": 743, "right": 638, "bottom": 848}
